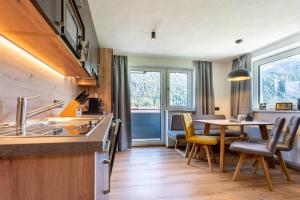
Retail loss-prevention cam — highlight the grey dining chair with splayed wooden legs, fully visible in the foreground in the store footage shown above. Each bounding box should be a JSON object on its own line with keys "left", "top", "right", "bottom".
{"left": 230, "top": 117, "right": 285, "bottom": 191}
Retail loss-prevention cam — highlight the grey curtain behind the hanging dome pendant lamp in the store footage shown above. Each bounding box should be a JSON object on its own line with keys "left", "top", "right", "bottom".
{"left": 231, "top": 54, "right": 252, "bottom": 117}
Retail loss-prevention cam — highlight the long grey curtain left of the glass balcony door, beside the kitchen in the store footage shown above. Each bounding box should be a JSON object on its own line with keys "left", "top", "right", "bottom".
{"left": 113, "top": 56, "right": 132, "bottom": 151}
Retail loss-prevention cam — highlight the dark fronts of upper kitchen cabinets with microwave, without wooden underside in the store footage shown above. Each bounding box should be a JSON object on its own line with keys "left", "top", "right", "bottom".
{"left": 33, "top": 0, "right": 100, "bottom": 76}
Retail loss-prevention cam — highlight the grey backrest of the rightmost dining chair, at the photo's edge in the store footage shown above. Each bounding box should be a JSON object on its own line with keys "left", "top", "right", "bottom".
{"left": 283, "top": 116, "right": 300, "bottom": 150}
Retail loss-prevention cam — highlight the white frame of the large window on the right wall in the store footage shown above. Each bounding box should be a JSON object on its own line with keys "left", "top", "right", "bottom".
{"left": 252, "top": 47, "right": 300, "bottom": 110}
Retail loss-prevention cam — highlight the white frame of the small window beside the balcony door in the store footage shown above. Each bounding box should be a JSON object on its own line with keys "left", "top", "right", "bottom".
{"left": 166, "top": 68, "right": 195, "bottom": 110}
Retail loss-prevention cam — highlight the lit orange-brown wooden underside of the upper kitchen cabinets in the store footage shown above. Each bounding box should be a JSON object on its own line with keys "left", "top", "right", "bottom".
{"left": 0, "top": 0, "right": 89, "bottom": 77}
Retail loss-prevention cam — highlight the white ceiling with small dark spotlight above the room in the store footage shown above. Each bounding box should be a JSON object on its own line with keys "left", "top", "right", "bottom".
{"left": 89, "top": 0, "right": 300, "bottom": 60}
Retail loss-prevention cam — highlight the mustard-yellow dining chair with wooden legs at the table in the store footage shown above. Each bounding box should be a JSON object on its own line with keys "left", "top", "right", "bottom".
{"left": 182, "top": 113, "right": 218, "bottom": 170}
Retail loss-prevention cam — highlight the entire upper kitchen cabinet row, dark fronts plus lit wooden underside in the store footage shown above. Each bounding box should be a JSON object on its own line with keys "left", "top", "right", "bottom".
{"left": 0, "top": 0, "right": 99, "bottom": 77}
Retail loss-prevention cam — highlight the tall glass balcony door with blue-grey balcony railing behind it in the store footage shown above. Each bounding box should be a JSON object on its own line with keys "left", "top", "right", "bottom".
{"left": 129, "top": 68, "right": 164, "bottom": 145}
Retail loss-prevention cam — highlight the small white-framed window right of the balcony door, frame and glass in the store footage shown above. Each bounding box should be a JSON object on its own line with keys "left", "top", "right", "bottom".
{"left": 167, "top": 70, "right": 194, "bottom": 109}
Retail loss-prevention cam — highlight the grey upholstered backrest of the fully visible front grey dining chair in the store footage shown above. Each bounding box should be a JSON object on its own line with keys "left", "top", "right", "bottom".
{"left": 267, "top": 117, "right": 285, "bottom": 154}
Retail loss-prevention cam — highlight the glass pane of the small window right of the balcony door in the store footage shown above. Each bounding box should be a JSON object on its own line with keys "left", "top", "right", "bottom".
{"left": 169, "top": 72, "right": 188, "bottom": 107}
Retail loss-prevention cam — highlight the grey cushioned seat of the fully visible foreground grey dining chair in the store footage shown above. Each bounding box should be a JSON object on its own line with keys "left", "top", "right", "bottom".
{"left": 230, "top": 141, "right": 273, "bottom": 157}
